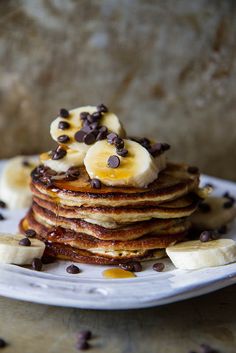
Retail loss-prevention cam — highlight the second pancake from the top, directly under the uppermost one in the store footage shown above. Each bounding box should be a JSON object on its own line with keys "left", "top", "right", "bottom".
{"left": 33, "top": 191, "right": 199, "bottom": 223}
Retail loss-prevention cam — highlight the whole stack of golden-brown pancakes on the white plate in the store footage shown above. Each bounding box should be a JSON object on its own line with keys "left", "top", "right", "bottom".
{"left": 21, "top": 163, "right": 199, "bottom": 265}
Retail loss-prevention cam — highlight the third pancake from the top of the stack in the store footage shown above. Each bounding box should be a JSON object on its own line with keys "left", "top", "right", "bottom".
{"left": 32, "top": 203, "right": 189, "bottom": 240}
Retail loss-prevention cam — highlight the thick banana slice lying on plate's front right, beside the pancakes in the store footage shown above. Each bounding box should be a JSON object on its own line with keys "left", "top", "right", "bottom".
{"left": 166, "top": 239, "right": 236, "bottom": 270}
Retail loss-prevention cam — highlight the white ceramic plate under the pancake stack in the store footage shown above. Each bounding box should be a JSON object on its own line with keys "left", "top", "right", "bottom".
{"left": 0, "top": 163, "right": 236, "bottom": 309}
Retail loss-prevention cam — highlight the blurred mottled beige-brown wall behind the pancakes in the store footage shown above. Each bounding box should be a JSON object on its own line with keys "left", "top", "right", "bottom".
{"left": 0, "top": 0, "right": 236, "bottom": 180}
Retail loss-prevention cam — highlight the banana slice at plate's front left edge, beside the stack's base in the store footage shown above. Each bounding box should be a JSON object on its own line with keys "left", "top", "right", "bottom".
{"left": 0, "top": 233, "right": 45, "bottom": 265}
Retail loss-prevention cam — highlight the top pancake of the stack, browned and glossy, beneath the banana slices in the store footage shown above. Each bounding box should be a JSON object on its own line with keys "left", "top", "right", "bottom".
{"left": 31, "top": 163, "right": 199, "bottom": 207}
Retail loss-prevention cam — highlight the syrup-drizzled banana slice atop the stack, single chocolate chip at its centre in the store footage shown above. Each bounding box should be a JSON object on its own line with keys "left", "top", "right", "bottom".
{"left": 84, "top": 140, "right": 162, "bottom": 187}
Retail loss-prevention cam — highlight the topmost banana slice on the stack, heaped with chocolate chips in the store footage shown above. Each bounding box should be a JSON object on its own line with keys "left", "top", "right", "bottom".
{"left": 50, "top": 105, "right": 125, "bottom": 153}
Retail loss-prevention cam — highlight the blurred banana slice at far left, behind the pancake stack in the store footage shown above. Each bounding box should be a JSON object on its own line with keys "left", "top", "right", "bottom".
{"left": 0, "top": 156, "right": 39, "bottom": 209}
